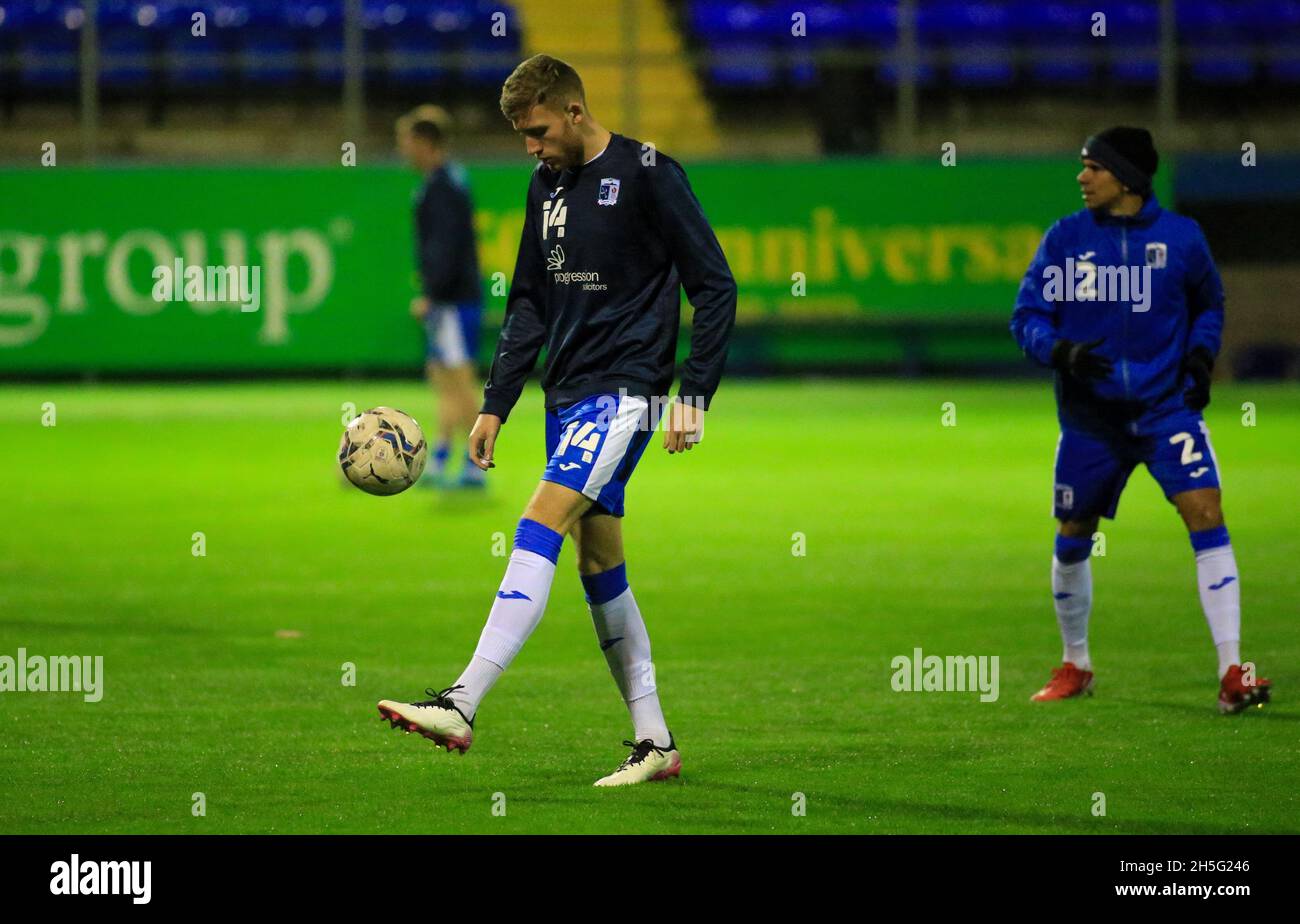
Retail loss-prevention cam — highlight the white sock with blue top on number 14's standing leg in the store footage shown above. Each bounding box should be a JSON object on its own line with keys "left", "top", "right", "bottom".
{"left": 582, "top": 563, "right": 670, "bottom": 747}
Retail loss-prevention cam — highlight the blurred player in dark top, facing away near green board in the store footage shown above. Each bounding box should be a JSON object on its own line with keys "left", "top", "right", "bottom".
{"left": 397, "top": 105, "right": 484, "bottom": 487}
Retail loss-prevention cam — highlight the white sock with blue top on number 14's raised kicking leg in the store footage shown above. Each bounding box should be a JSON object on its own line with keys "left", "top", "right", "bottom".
{"left": 451, "top": 517, "right": 564, "bottom": 719}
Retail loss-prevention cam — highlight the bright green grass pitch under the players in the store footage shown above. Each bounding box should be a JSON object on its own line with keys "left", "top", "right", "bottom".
{"left": 0, "top": 381, "right": 1300, "bottom": 833}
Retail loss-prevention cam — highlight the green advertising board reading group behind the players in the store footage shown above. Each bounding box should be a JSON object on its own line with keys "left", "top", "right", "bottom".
{"left": 0, "top": 157, "right": 1159, "bottom": 374}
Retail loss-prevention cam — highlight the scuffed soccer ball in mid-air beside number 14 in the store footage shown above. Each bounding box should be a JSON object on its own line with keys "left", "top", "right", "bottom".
{"left": 338, "top": 407, "right": 429, "bottom": 495}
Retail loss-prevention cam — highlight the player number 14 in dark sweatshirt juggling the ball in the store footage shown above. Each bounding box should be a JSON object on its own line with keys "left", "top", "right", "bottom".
{"left": 380, "top": 55, "right": 736, "bottom": 786}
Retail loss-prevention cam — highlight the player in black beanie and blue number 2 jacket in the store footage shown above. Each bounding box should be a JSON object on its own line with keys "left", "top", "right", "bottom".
{"left": 1011, "top": 126, "right": 1269, "bottom": 712}
